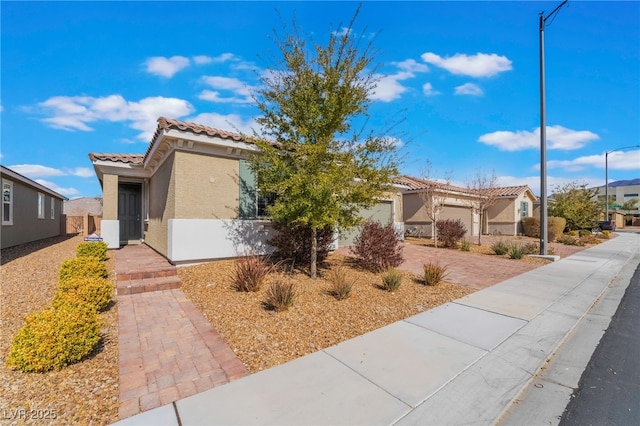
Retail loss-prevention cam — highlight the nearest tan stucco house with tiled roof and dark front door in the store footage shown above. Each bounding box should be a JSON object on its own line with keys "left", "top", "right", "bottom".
{"left": 89, "top": 117, "right": 402, "bottom": 264}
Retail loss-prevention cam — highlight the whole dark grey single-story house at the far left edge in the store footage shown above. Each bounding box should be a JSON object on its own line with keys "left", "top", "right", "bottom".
{"left": 0, "top": 166, "right": 67, "bottom": 248}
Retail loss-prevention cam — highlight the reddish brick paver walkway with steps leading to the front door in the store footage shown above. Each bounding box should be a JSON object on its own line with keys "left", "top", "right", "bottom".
{"left": 115, "top": 245, "right": 248, "bottom": 419}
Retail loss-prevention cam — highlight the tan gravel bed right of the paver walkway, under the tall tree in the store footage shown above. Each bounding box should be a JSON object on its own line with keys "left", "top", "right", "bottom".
{"left": 178, "top": 255, "right": 474, "bottom": 373}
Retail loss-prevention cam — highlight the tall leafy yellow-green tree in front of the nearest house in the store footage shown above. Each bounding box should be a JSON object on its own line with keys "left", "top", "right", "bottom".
{"left": 251, "top": 12, "right": 399, "bottom": 278}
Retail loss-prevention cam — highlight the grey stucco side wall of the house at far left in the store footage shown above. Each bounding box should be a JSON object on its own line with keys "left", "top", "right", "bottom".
{"left": 0, "top": 179, "right": 62, "bottom": 248}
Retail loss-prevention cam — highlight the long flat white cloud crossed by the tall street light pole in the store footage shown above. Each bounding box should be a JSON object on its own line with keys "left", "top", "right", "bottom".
{"left": 478, "top": 126, "right": 600, "bottom": 151}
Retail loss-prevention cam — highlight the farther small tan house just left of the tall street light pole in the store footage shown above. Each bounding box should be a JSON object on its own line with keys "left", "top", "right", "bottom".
{"left": 483, "top": 185, "right": 537, "bottom": 235}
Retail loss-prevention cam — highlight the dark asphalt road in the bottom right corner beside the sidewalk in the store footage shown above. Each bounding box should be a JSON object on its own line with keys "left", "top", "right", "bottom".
{"left": 560, "top": 258, "right": 640, "bottom": 426}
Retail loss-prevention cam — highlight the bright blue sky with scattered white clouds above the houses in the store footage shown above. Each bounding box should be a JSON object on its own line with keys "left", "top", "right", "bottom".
{"left": 0, "top": 1, "right": 640, "bottom": 198}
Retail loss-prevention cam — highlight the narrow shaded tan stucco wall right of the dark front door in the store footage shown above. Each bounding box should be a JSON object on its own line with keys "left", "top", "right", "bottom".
{"left": 144, "top": 153, "right": 175, "bottom": 256}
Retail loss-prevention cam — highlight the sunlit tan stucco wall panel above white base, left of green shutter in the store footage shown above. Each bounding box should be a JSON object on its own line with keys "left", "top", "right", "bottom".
{"left": 174, "top": 151, "right": 240, "bottom": 219}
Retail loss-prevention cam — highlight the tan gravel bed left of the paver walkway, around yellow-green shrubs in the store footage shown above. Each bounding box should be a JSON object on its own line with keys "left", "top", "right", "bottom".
{"left": 0, "top": 236, "right": 118, "bottom": 425}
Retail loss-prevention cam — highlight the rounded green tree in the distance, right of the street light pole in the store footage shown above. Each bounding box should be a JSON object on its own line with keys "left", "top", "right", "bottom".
{"left": 549, "top": 182, "right": 601, "bottom": 230}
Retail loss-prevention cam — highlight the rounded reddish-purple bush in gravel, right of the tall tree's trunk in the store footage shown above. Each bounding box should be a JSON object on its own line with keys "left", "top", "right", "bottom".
{"left": 351, "top": 222, "right": 403, "bottom": 272}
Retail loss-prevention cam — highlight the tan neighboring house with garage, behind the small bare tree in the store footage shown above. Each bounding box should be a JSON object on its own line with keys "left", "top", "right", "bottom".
{"left": 394, "top": 176, "right": 480, "bottom": 237}
